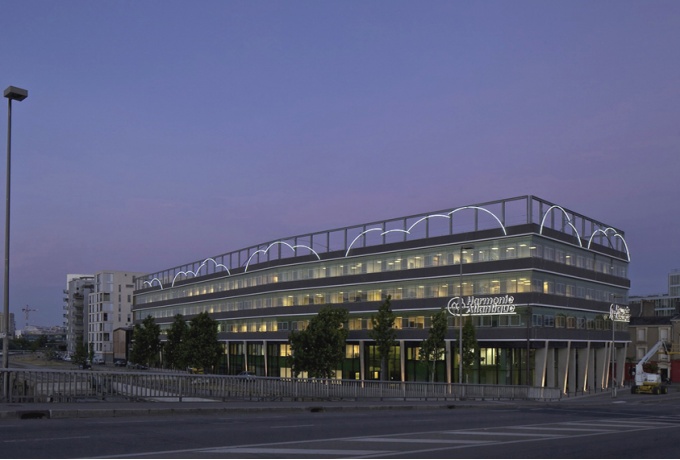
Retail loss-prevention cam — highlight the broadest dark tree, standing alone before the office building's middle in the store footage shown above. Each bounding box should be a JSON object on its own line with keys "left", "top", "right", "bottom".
{"left": 288, "top": 307, "right": 349, "bottom": 378}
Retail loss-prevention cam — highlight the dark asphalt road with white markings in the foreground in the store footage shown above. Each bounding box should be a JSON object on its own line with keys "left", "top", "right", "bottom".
{"left": 0, "top": 394, "right": 680, "bottom": 458}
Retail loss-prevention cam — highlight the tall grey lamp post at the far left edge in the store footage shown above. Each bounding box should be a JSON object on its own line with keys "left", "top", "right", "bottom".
{"left": 2, "top": 86, "right": 28, "bottom": 398}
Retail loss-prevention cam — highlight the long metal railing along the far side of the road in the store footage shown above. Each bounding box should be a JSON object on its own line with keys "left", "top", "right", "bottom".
{"left": 0, "top": 369, "right": 561, "bottom": 403}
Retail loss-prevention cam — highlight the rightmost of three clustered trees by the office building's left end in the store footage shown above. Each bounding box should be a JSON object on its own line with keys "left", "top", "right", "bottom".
{"left": 180, "top": 312, "right": 224, "bottom": 370}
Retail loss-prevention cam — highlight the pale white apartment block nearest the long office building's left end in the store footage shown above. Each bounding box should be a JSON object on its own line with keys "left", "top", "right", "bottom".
{"left": 87, "top": 271, "right": 143, "bottom": 363}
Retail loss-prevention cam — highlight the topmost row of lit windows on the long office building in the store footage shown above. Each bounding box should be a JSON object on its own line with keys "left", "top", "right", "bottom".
{"left": 135, "top": 237, "right": 627, "bottom": 305}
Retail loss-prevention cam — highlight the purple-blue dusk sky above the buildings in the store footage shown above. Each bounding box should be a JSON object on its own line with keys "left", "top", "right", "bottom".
{"left": 0, "top": 0, "right": 680, "bottom": 328}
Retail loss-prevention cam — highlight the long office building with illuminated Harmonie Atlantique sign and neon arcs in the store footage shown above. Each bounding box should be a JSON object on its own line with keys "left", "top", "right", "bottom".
{"left": 133, "top": 196, "right": 630, "bottom": 392}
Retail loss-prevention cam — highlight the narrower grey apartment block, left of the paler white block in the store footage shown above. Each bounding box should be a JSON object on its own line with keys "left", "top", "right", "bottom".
{"left": 64, "top": 275, "right": 94, "bottom": 355}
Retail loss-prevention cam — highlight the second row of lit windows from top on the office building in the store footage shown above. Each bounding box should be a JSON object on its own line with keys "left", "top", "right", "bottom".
{"left": 135, "top": 272, "right": 621, "bottom": 320}
